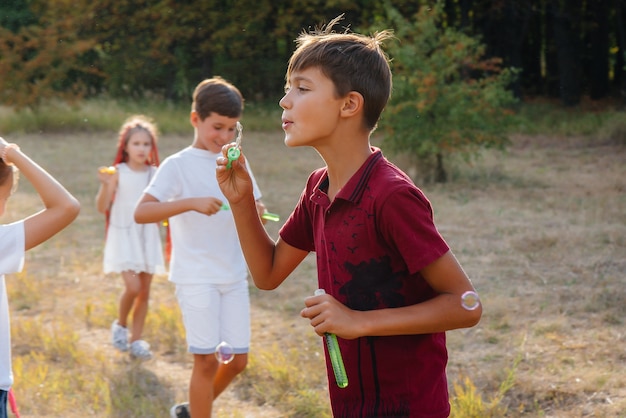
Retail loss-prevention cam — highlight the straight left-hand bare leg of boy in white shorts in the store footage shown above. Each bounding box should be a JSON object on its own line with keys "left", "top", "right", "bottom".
{"left": 189, "top": 354, "right": 218, "bottom": 418}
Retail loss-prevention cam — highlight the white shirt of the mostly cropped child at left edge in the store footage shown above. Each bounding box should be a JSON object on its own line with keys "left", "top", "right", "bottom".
{"left": 0, "top": 221, "right": 25, "bottom": 391}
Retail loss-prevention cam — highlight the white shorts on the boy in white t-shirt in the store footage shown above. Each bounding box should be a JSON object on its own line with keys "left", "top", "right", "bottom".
{"left": 176, "top": 280, "right": 250, "bottom": 354}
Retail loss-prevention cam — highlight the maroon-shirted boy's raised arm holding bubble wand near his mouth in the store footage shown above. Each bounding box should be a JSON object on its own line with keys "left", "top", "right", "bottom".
{"left": 216, "top": 144, "right": 308, "bottom": 290}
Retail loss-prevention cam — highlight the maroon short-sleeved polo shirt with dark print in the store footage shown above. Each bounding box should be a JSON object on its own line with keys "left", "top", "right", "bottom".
{"left": 280, "top": 148, "right": 450, "bottom": 418}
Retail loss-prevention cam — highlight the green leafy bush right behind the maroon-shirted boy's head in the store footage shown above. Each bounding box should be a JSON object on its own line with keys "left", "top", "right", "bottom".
{"left": 372, "top": 4, "right": 516, "bottom": 182}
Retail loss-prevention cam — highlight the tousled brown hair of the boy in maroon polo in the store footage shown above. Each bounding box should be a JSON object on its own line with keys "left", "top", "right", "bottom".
{"left": 286, "top": 15, "right": 392, "bottom": 130}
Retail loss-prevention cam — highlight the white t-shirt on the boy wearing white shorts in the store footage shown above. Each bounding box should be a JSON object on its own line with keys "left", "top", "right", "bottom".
{"left": 146, "top": 147, "right": 261, "bottom": 284}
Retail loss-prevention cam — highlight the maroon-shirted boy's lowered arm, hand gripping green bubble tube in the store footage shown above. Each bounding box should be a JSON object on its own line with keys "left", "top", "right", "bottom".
{"left": 301, "top": 251, "right": 482, "bottom": 339}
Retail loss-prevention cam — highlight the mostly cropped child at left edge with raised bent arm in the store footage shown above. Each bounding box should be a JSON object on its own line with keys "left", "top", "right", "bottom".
{"left": 0, "top": 138, "right": 80, "bottom": 418}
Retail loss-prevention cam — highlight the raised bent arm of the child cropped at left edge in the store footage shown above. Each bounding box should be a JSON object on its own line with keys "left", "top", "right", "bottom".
{"left": 0, "top": 138, "right": 80, "bottom": 250}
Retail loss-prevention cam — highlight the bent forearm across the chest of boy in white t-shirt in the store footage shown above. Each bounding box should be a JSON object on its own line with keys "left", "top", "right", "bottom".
{"left": 135, "top": 193, "right": 222, "bottom": 224}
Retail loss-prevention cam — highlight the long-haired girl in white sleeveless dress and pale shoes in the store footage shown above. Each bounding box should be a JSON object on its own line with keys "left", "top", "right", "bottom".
{"left": 96, "top": 115, "right": 165, "bottom": 360}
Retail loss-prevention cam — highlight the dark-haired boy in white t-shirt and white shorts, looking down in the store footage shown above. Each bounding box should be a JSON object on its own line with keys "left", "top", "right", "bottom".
{"left": 135, "top": 77, "right": 265, "bottom": 418}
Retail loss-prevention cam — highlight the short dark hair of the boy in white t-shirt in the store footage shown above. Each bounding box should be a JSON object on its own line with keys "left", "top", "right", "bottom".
{"left": 191, "top": 76, "right": 243, "bottom": 120}
